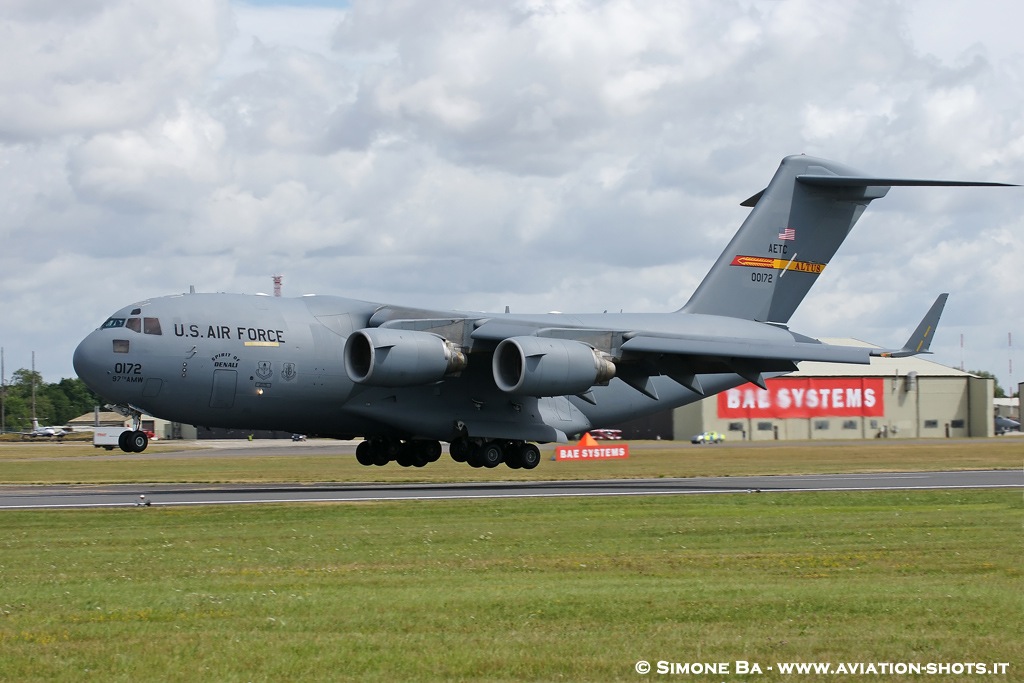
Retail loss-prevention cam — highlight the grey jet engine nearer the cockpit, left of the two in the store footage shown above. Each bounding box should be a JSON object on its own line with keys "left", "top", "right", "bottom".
{"left": 344, "top": 328, "right": 466, "bottom": 387}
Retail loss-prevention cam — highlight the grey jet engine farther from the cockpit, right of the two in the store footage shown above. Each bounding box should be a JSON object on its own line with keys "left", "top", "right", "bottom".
{"left": 492, "top": 337, "right": 615, "bottom": 396}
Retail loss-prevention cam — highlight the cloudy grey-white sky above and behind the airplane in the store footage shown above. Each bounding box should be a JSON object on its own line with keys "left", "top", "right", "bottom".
{"left": 0, "top": 0, "right": 1024, "bottom": 387}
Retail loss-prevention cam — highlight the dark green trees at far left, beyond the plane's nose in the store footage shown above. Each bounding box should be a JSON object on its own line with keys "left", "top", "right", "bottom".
{"left": 0, "top": 368, "right": 102, "bottom": 431}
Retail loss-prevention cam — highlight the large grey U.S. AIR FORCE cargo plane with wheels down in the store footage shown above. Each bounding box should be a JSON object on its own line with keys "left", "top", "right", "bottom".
{"left": 74, "top": 155, "right": 1012, "bottom": 469}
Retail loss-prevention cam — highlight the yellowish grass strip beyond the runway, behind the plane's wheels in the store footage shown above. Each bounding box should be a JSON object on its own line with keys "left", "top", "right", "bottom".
{"left": 0, "top": 438, "right": 1024, "bottom": 484}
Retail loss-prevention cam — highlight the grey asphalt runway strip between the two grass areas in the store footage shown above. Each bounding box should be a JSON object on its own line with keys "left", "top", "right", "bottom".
{"left": 0, "top": 470, "right": 1024, "bottom": 510}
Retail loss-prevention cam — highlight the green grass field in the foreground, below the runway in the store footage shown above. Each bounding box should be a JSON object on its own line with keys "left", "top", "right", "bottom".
{"left": 0, "top": 490, "right": 1024, "bottom": 682}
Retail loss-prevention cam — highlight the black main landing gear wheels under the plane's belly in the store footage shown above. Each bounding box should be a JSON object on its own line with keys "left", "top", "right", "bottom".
{"left": 355, "top": 437, "right": 541, "bottom": 470}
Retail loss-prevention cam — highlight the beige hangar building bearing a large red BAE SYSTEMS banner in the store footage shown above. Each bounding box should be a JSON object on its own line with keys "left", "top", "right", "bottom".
{"left": 673, "top": 339, "right": 994, "bottom": 441}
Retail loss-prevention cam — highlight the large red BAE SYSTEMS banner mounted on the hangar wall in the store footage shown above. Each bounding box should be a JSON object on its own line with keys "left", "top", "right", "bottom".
{"left": 718, "top": 377, "right": 885, "bottom": 419}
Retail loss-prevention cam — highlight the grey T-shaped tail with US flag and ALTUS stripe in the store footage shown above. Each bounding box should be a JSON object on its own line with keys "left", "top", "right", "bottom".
{"left": 680, "top": 156, "right": 1004, "bottom": 324}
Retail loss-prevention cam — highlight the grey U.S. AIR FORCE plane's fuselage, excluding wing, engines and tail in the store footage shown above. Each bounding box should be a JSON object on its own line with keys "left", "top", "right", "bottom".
{"left": 74, "top": 294, "right": 757, "bottom": 441}
